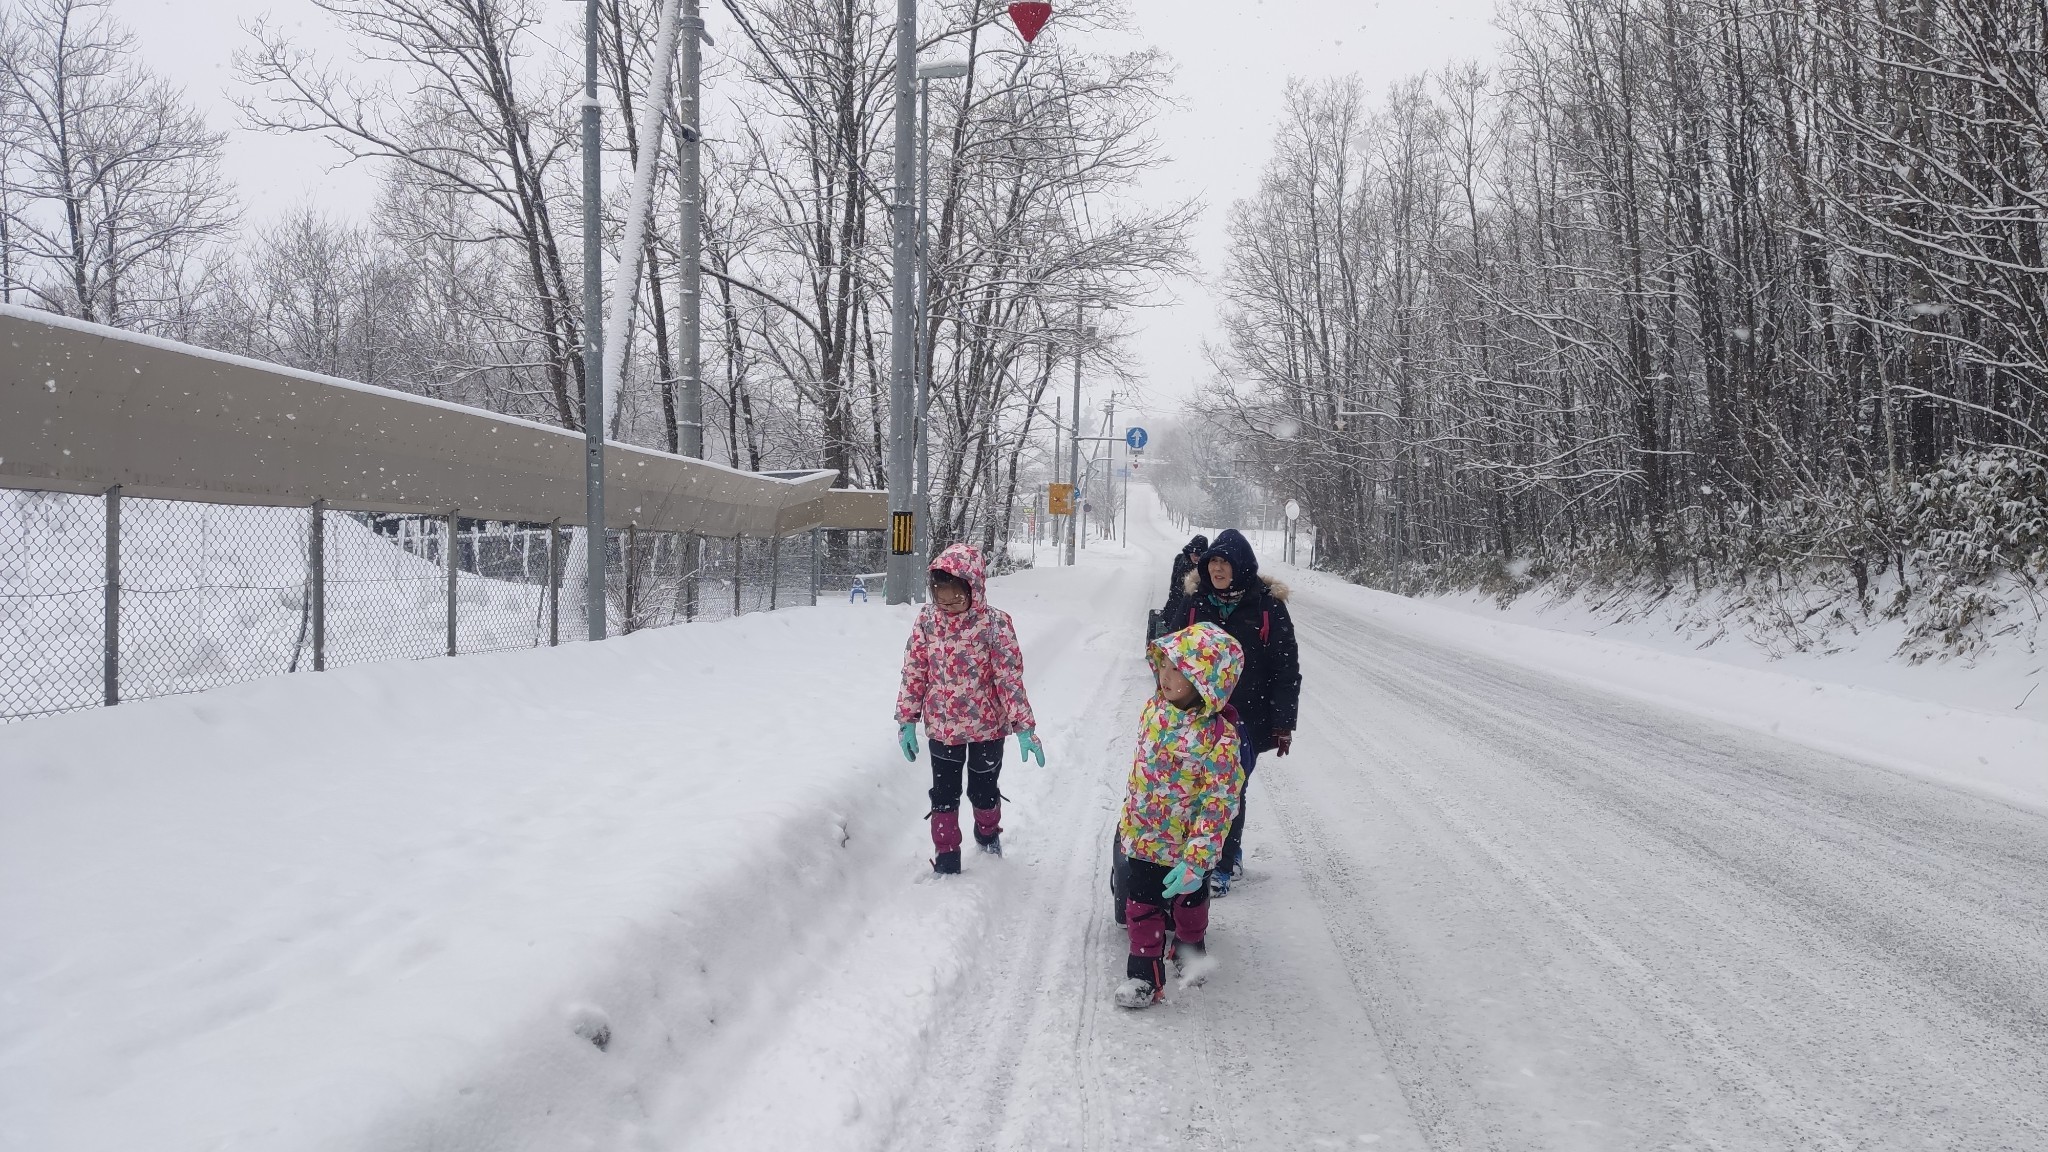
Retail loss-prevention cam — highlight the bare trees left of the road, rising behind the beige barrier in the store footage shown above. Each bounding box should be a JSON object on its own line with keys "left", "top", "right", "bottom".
{"left": 0, "top": 0, "right": 1194, "bottom": 561}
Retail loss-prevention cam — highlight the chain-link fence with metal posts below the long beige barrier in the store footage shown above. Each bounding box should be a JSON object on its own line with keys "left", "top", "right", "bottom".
{"left": 0, "top": 490, "right": 887, "bottom": 719}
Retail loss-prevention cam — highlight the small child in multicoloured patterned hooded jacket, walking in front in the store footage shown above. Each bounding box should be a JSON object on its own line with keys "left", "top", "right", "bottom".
{"left": 1116, "top": 623, "right": 1245, "bottom": 1009}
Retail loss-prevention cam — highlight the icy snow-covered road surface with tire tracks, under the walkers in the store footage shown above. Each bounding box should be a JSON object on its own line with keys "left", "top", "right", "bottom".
{"left": 864, "top": 496, "right": 2048, "bottom": 1152}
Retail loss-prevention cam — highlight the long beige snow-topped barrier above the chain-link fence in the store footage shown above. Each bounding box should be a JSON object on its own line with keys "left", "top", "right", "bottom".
{"left": 0, "top": 305, "right": 887, "bottom": 535}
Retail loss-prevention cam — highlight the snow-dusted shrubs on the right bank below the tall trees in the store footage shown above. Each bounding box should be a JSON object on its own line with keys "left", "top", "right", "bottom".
{"left": 1346, "top": 449, "right": 2048, "bottom": 662}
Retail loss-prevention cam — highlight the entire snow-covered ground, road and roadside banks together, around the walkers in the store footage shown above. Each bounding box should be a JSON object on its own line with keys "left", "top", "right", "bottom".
{"left": 0, "top": 488, "right": 2048, "bottom": 1152}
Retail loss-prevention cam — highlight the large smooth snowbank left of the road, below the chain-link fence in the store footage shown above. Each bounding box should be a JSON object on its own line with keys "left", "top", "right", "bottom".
{"left": 0, "top": 603, "right": 926, "bottom": 1152}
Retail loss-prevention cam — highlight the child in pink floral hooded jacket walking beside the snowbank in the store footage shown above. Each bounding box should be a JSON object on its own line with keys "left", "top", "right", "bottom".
{"left": 897, "top": 543, "right": 1044, "bottom": 873}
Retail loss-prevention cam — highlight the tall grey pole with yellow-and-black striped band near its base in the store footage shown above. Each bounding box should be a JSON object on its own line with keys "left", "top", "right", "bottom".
{"left": 880, "top": 0, "right": 920, "bottom": 605}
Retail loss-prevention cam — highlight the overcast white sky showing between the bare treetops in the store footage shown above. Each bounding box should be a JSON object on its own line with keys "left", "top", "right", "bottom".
{"left": 115, "top": 0, "right": 1495, "bottom": 428}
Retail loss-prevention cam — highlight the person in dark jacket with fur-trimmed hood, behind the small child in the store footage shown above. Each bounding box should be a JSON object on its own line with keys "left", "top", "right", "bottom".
{"left": 1169, "top": 529, "right": 1300, "bottom": 896}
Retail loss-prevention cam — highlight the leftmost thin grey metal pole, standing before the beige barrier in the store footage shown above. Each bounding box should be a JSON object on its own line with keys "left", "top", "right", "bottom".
{"left": 584, "top": 0, "right": 604, "bottom": 640}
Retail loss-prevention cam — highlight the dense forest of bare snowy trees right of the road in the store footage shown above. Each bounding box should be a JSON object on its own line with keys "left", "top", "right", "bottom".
{"left": 1208, "top": 0, "right": 2048, "bottom": 647}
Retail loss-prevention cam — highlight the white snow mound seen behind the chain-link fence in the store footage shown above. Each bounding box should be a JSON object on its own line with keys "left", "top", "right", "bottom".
{"left": 0, "top": 490, "right": 552, "bottom": 717}
